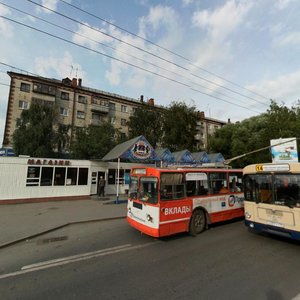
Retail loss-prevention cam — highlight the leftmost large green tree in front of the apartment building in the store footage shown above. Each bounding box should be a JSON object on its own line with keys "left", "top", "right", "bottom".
{"left": 13, "top": 103, "right": 57, "bottom": 157}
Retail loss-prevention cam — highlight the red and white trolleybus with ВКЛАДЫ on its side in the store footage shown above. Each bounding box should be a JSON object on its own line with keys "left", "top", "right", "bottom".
{"left": 127, "top": 167, "right": 244, "bottom": 237}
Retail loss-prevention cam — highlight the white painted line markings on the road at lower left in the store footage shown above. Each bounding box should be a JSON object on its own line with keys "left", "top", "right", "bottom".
{"left": 0, "top": 242, "right": 156, "bottom": 280}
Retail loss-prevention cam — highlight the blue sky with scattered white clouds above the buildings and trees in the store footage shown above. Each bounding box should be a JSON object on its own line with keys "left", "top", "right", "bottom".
{"left": 0, "top": 0, "right": 300, "bottom": 145}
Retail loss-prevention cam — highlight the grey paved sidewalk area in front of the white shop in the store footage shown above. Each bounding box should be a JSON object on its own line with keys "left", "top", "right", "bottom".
{"left": 0, "top": 195, "right": 126, "bottom": 249}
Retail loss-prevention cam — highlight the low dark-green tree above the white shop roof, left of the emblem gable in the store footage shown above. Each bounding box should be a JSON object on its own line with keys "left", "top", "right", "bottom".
{"left": 71, "top": 122, "right": 118, "bottom": 159}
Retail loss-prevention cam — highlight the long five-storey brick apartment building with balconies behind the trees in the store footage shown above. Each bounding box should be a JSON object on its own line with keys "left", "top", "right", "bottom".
{"left": 3, "top": 72, "right": 226, "bottom": 150}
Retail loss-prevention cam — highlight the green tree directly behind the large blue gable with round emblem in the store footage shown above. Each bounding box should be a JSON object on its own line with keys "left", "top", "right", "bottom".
{"left": 127, "top": 105, "right": 162, "bottom": 148}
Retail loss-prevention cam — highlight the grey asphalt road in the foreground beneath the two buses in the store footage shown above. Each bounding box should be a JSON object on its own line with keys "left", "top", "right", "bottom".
{"left": 0, "top": 220, "right": 300, "bottom": 300}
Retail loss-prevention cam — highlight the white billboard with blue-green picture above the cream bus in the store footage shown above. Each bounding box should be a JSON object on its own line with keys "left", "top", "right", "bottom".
{"left": 271, "top": 138, "right": 298, "bottom": 163}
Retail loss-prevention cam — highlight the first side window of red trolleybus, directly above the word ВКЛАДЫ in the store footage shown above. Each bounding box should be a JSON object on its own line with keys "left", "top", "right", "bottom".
{"left": 160, "top": 173, "right": 184, "bottom": 200}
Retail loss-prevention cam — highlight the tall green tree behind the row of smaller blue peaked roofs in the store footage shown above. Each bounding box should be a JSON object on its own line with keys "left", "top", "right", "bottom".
{"left": 162, "top": 102, "right": 199, "bottom": 152}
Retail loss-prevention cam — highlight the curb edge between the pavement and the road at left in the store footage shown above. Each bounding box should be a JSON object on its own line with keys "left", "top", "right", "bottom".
{"left": 0, "top": 216, "right": 126, "bottom": 249}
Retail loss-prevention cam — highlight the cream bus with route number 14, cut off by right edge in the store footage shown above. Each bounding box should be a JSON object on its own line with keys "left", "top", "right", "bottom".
{"left": 243, "top": 163, "right": 300, "bottom": 240}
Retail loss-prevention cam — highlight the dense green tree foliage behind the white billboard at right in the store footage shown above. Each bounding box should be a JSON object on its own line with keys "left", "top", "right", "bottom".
{"left": 210, "top": 101, "right": 300, "bottom": 167}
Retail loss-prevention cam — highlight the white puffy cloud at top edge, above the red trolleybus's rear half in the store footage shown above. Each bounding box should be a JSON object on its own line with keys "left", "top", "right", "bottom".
{"left": 192, "top": 0, "right": 252, "bottom": 41}
